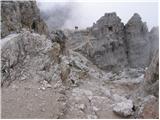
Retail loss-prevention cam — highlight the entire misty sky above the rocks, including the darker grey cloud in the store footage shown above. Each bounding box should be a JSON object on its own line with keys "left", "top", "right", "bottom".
{"left": 38, "top": 0, "right": 158, "bottom": 29}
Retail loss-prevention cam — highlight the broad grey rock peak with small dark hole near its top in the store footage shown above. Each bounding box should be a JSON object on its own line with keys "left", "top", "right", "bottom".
{"left": 70, "top": 13, "right": 127, "bottom": 70}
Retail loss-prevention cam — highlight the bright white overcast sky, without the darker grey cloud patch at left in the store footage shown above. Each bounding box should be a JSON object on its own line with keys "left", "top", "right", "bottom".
{"left": 37, "top": 0, "right": 158, "bottom": 29}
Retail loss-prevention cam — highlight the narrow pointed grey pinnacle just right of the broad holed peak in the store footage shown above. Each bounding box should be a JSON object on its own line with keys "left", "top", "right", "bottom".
{"left": 125, "top": 13, "right": 150, "bottom": 67}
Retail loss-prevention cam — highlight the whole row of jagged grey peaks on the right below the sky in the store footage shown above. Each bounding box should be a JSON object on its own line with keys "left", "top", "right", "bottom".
{"left": 70, "top": 13, "right": 159, "bottom": 70}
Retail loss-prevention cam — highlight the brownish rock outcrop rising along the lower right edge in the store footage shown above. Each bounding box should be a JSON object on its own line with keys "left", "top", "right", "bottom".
{"left": 131, "top": 50, "right": 159, "bottom": 119}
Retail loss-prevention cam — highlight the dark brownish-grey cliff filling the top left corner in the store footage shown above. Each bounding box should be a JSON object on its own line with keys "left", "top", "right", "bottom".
{"left": 1, "top": 1, "right": 48, "bottom": 37}
